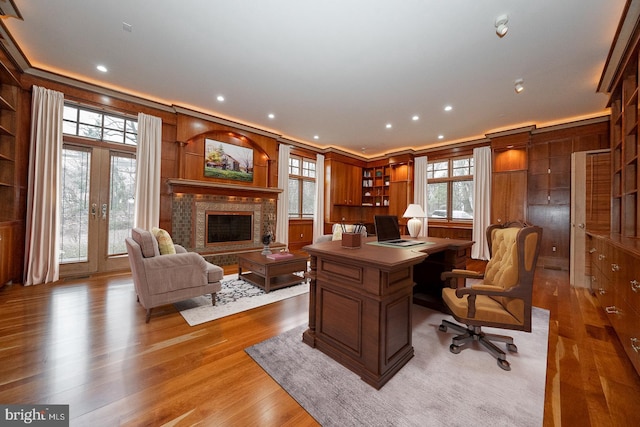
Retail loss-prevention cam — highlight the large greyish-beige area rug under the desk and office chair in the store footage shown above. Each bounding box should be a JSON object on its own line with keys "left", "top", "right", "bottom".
{"left": 246, "top": 305, "right": 549, "bottom": 427}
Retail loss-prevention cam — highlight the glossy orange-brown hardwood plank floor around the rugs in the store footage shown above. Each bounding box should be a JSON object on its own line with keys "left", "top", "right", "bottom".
{"left": 0, "top": 264, "right": 640, "bottom": 427}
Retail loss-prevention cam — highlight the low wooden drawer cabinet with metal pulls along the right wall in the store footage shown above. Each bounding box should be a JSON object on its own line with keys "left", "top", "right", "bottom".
{"left": 587, "top": 234, "right": 640, "bottom": 374}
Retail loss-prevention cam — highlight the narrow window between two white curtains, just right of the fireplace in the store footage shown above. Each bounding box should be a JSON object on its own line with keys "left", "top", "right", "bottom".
{"left": 289, "top": 155, "right": 316, "bottom": 218}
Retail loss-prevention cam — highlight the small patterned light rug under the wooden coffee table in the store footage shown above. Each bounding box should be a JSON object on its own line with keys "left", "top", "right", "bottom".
{"left": 174, "top": 274, "right": 309, "bottom": 326}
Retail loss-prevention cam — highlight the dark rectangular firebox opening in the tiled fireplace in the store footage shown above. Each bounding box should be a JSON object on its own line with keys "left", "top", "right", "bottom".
{"left": 205, "top": 211, "right": 253, "bottom": 246}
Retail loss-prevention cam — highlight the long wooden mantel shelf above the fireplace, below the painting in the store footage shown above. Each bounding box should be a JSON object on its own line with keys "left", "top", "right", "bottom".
{"left": 167, "top": 178, "right": 282, "bottom": 199}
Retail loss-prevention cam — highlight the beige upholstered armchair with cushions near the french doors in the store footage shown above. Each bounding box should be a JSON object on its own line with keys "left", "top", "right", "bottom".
{"left": 125, "top": 228, "right": 224, "bottom": 323}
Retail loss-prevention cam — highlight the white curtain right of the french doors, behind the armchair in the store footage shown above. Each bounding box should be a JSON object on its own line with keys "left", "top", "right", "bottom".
{"left": 133, "top": 113, "right": 162, "bottom": 230}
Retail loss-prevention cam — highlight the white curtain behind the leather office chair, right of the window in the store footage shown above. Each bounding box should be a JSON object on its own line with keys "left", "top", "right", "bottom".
{"left": 471, "top": 147, "right": 491, "bottom": 260}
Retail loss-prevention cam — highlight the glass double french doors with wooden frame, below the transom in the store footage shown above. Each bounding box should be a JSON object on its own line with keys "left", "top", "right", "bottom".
{"left": 60, "top": 144, "right": 136, "bottom": 277}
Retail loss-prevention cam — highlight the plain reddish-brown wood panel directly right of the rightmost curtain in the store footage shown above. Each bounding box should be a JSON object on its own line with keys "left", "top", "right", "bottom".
{"left": 491, "top": 171, "right": 527, "bottom": 223}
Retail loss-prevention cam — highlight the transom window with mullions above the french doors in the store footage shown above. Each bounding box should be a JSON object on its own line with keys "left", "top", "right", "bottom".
{"left": 62, "top": 104, "right": 138, "bottom": 145}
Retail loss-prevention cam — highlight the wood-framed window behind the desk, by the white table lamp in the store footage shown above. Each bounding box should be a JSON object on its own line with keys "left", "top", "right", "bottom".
{"left": 427, "top": 157, "right": 473, "bottom": 221}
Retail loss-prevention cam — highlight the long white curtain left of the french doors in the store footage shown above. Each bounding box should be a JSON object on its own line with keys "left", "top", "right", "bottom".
{"left": 24, "top": 86, "right": 64, "bottom": 286}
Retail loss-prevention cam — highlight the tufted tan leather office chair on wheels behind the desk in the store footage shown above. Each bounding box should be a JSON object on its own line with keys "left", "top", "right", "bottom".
{"left": 440, "top": 222, "right": 542, "bottom": 371}
